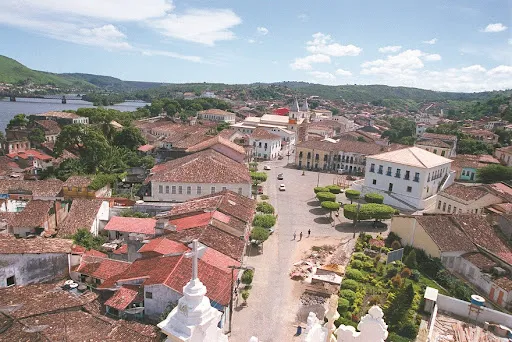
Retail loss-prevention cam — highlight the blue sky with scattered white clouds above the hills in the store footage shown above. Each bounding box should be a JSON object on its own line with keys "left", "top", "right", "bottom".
{"left": 0, "top": 0, "right": 512, "bottom": 91}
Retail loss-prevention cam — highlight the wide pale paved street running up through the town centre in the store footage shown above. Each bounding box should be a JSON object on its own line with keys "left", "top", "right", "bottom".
{"left": 230, "top": 157, "right": 384, "bottom": 342}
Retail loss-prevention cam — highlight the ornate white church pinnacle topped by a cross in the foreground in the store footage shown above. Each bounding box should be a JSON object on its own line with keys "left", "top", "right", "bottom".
{"left": 158, "top": 240, "right": 228, "bottom": 342}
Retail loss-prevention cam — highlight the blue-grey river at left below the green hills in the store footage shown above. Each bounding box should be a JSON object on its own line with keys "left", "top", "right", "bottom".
{"left": 0, "top": 97, "right": 148, "bottom": 133}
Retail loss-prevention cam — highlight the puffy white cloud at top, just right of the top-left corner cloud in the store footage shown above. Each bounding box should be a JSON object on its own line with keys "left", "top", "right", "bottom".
{"left": 148, "top": 9, "right": 242, "bottom": 45}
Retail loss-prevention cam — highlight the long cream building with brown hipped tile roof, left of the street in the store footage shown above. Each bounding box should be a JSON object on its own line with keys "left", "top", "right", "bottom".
{"left": 144, "top": 149, "right": 252, "bottom": 202}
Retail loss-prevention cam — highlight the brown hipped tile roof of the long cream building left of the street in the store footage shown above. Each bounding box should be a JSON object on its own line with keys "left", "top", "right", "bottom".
{"left": 146, "top": 149, "right": 252, "bottom": 184}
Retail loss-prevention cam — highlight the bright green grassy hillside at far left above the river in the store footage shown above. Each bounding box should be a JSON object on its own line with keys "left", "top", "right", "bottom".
{"left": 0, "top": 55, "right": 96, "bottom": 89}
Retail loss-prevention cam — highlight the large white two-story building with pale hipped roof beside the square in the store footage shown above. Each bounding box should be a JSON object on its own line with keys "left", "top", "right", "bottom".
{"left": 353, "top": 147, "right": 455, "bottom": 210}
